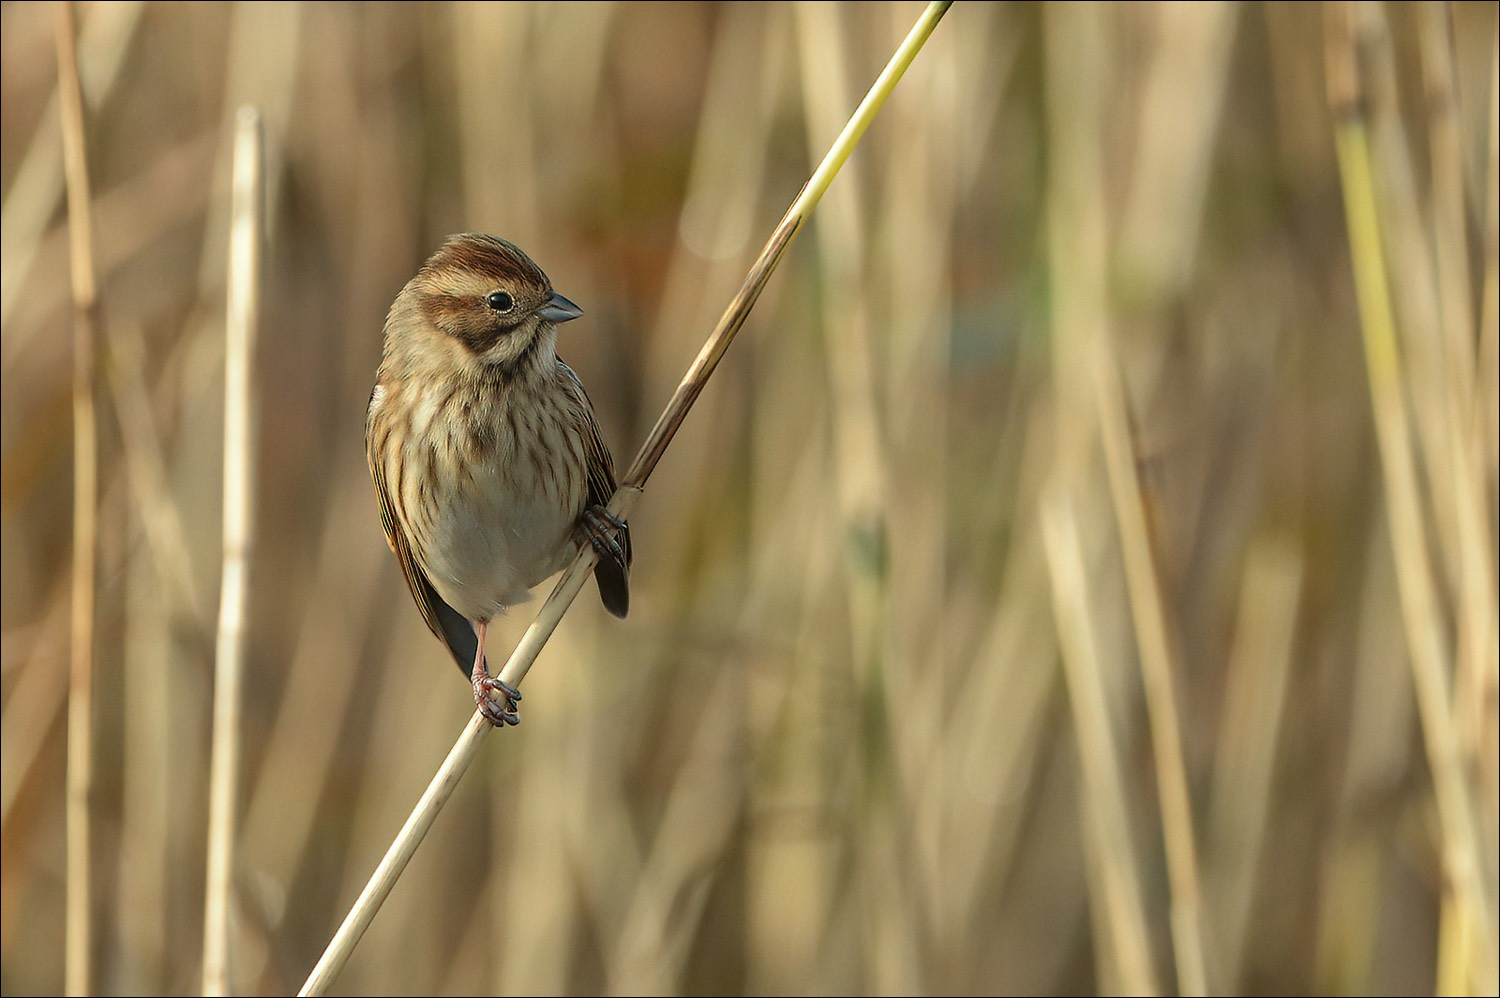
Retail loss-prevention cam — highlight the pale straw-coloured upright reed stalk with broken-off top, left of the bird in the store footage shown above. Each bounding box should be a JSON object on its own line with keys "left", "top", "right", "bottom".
{"left": 203, "top": 107, "right": 264, "bottom": 995}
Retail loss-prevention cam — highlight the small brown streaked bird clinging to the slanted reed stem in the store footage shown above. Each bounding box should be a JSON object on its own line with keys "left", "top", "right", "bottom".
{"left": 365, "top": 233, "right": 630, "bottom": 726}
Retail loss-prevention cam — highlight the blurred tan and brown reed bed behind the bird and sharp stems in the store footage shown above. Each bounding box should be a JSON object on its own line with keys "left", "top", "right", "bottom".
{"left": 0, "top": 3, "right": 1497, "bottom": 995}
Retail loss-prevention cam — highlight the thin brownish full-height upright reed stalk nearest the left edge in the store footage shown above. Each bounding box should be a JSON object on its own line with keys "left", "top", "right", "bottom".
{"left": 57, "top": 3, "right": 99, "bottom": 995}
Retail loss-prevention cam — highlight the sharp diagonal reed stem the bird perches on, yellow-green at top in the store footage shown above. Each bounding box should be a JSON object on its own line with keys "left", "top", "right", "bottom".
{"left": 299, "top": 0, "right": 953, "bottom": 995}
